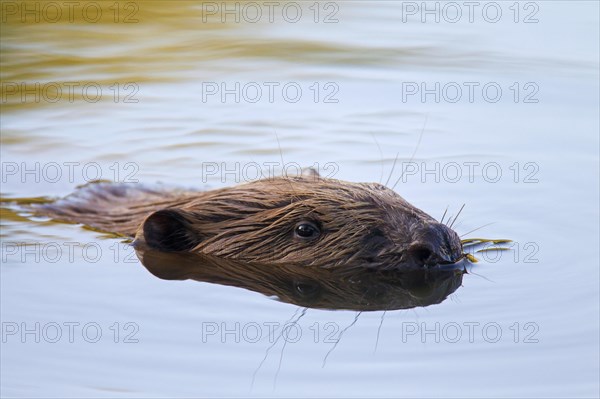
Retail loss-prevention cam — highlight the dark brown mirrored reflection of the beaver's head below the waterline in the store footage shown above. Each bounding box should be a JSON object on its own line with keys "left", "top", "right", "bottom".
{"left": 136, "top": 250, "right": 465, "bottom": 311}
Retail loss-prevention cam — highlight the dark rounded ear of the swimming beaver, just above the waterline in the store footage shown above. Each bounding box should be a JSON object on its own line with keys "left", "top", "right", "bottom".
{"left": 143, "top": 209, "right": 202, "bottom": 252}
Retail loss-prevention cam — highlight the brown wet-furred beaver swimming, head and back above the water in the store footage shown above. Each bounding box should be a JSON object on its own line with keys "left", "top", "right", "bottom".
{"left": 38, "top": 170, "right": 463, "bottom": 269}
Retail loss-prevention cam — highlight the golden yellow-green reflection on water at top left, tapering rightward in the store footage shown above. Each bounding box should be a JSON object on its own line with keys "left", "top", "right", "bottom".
{"left": 0, "top": 1, "right": 483, "bottom": 112}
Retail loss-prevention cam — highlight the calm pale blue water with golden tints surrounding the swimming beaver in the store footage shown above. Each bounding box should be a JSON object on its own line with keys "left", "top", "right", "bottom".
{"left": 0, "top": 1, "right": 600, "bottom": 398}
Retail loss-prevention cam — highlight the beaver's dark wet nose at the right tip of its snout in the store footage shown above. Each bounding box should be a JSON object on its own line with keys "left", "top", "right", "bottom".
{"left": 406, "top": 223, "right": 462, "bottom": 266}
